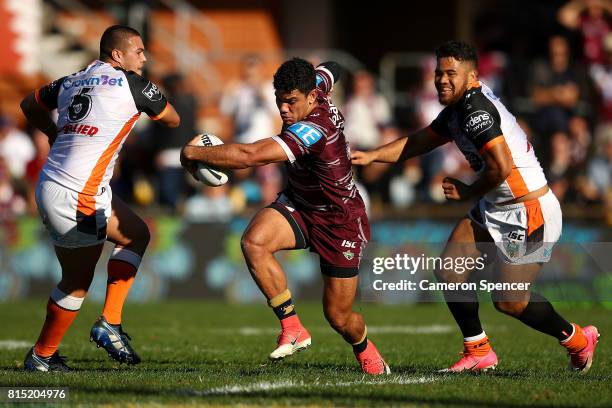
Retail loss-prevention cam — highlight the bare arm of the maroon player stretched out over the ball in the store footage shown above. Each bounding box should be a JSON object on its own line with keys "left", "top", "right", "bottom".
{"left": 181, "top": 136, "right": 289, "bottom": 171}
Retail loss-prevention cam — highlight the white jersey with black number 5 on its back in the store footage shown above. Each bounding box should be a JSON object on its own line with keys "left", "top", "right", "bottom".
{"left": 35, "top": 61, "right": 168, "bottom": 215}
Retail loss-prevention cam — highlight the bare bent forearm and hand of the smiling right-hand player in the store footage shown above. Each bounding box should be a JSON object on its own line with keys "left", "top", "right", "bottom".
{"left": 442, "top": 136, "right": 512, "bottom": 201}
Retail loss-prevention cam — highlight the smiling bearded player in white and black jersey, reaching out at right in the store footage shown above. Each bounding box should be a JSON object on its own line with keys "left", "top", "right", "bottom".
{"left": 352, "top": 41, "right": 599, "bottom": 372}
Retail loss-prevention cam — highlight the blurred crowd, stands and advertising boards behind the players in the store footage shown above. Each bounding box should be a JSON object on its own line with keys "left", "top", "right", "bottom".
{"left": 0, "top": 0, "right": 612, "bottom": 302}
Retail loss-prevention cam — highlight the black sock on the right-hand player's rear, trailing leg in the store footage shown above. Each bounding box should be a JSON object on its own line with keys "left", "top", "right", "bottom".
{"left": 518, "top": 292, "right": 574, "bottom": 341}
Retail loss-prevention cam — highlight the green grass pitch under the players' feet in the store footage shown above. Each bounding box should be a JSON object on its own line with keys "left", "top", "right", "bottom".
{"left": 0, "top": 300, "right": 612, "bottom": 407}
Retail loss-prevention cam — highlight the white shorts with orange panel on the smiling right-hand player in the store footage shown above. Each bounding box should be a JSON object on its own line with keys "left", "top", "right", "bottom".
{"left": 468, "top": 190, "right": 562, "bottom": 264}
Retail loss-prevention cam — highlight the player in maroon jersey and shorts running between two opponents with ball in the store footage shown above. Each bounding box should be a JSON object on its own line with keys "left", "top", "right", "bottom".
{"left": 182, "top": 58, "right": 390, "bottom": 374}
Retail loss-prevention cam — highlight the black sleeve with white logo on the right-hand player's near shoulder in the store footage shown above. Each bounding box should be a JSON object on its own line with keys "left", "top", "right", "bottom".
{"left": 457, "top": 90, "right": 502, "bottom": 150}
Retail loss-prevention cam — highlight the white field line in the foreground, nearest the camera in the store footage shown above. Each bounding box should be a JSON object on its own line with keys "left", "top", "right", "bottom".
{"left": 196, "top": 375, "right": 437, "bottom": 395}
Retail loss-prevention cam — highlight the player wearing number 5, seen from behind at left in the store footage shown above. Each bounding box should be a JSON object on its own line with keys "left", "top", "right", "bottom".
{"left": 21, "top": 25, "right": 180, "bottom": 371}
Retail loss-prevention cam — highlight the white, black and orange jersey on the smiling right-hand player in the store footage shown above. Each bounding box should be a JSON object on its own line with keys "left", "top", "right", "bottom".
{"left": 429, "top": 83, "right": 547, "bottom": 204}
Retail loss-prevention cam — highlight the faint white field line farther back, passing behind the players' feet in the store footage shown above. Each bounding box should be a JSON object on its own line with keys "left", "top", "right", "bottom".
{"left": 212, "top": 324, "right": 457, "bottom": 336}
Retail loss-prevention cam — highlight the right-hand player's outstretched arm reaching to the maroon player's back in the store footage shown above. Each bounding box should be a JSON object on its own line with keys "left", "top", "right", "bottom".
{"left": 351, "top": 128, "right": 449, "bottom": 166}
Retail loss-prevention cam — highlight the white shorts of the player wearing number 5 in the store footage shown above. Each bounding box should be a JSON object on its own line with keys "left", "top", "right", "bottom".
{"left": 36, "top": 179, "right": 113, "bottom": 248}
